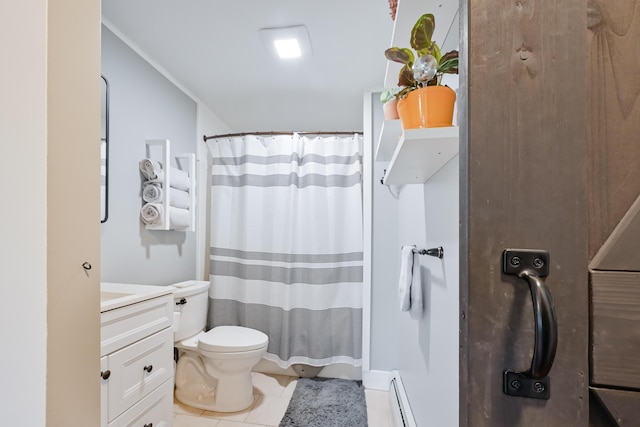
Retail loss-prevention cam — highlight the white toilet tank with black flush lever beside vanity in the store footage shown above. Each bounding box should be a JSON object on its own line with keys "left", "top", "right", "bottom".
{"left": 173, "top": 280, "right": 209, "bottom": 342}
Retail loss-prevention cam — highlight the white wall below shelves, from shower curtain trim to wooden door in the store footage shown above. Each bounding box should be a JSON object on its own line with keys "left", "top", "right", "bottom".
{"left": 365, "top": 83, "right": 459, "bottom": 427}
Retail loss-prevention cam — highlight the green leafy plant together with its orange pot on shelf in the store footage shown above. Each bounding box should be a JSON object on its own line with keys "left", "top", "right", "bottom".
{"left": 384, "top": 13, "right": 458, "bottom": 129}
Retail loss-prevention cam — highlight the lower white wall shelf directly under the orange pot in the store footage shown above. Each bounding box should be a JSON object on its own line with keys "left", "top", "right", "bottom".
{"left": 380, "top": 126, "right": 459, "bottom": 185}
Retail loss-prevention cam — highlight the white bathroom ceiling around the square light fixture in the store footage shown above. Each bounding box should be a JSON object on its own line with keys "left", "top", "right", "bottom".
{"left": 102, "top": 0, "right": 393, "bottom": 132}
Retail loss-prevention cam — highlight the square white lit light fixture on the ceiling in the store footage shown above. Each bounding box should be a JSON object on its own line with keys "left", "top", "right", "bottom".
{"left": 259, "top": 25, "right": 311, "bottom": 59}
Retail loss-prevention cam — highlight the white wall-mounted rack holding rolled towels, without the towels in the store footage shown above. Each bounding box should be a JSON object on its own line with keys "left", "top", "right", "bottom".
{"left": 145, "top": 139, "right": 197, "bottom": 231}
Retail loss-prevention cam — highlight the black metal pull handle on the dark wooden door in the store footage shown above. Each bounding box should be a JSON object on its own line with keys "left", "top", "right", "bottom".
{"left": 503, "top": 249, "right": 558, "bottom": 399}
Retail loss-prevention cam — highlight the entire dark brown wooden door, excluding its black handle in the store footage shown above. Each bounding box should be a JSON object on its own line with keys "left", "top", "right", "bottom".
{"left": 459, "top": 0, "right": 640, "bottom": 427}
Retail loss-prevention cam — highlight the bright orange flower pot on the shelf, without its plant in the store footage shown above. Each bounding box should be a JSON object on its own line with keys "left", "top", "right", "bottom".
{"left": 398, "top": 86, "right": 456, "bottom": 129}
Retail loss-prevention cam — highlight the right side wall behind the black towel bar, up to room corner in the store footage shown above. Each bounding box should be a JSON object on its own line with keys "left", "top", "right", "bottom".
{"left": 398, "top": 156, "right": 459, "bottom": 427}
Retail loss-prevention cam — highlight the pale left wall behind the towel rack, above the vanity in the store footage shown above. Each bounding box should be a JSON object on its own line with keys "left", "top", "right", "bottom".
{"left": 101, "top": 26, "right": 202, "bottom": 285}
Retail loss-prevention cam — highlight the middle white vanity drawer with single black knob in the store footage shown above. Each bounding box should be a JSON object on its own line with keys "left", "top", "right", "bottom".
{"left": 107, "top": 328, "right": 173, "bottom": 426}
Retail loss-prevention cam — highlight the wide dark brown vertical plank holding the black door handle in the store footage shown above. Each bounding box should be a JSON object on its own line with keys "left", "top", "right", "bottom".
{"left": 459, "top": 0, "right": 589, "bottom": 427}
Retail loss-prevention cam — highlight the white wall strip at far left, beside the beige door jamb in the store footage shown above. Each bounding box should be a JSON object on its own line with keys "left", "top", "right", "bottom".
{"left": 0, "top": 1, "right": 47, "bottom": 426}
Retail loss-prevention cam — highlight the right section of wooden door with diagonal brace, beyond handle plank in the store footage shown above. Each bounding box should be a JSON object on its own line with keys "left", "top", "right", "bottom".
{"left": 587, "top": 0, "right": 640, "bottom": 426}
